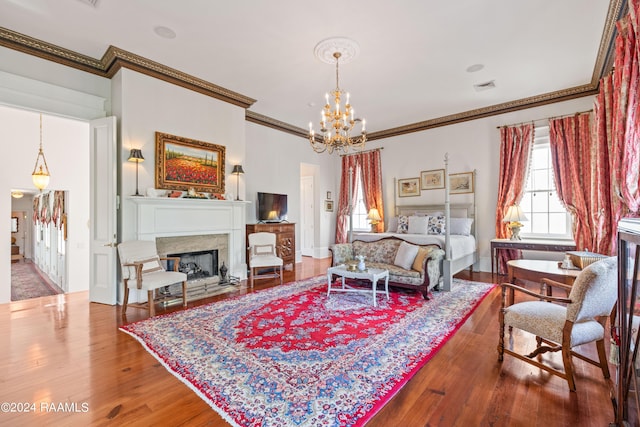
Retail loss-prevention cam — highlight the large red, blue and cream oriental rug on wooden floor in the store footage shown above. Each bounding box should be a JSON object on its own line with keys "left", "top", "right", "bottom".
{"left": 120, "top": 276, "right": 495, "bottom": 427}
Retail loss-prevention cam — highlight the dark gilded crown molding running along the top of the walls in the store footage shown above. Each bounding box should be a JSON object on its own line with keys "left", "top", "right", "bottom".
{"left": 0, "top": 0, "right": 628, "bottom": 141}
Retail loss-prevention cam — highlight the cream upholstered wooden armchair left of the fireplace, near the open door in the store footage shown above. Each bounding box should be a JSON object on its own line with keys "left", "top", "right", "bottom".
{"left": 118, "top": 240, "right": 187, "bottom": 317}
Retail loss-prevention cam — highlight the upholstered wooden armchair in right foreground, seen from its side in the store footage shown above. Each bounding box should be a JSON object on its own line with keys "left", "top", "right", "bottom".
{"left": 498, "top": 257, "right": 618, "bottom": 391}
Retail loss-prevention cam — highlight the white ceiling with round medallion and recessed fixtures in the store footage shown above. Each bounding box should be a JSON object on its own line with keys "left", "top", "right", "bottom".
{"left": 0, "top": 0, "right": 609, "bottom": 132}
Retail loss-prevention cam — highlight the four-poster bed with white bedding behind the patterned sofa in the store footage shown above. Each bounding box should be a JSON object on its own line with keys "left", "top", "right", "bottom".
{"left": 352, "top": 156, "right": 478, "bottom": 291}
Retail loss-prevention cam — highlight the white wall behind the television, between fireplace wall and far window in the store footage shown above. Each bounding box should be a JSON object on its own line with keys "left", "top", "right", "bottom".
{"left": 244, "top": 122, "right": 340, "bottom": 261}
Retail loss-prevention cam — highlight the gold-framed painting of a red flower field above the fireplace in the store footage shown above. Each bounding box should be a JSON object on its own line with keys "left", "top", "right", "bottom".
{"left": 156, "top": 132, "right": 225, "bottom": 194}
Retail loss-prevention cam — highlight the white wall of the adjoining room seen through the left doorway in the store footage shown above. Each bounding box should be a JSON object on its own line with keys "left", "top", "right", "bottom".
{"left": 0, "top": 105, "right": 89, "bottom": 303}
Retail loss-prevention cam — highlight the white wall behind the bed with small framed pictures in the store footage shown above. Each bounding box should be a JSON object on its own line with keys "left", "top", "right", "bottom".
{"left": 369, "top": 96, "right": 594, "bottom": 271}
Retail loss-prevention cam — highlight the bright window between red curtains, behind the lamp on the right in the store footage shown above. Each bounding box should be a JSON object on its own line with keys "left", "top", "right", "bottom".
{"left": 520, "top": 127, "right": 573, "bottom": 239}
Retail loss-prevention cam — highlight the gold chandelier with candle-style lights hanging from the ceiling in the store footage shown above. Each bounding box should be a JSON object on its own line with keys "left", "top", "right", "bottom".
{"left": 309, "top": 39, "right": 367, "bottom": 154}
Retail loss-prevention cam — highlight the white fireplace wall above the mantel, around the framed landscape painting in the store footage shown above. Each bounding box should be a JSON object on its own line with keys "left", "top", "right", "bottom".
{"left": 112, "top": 69, "right": 245, "bottom": 246}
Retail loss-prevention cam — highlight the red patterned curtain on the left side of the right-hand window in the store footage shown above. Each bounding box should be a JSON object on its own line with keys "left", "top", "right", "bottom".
{"left": 496, "top": 123, "right": 533, "bottom": 272}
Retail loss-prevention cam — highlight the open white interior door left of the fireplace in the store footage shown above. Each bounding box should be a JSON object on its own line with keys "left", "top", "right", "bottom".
{"left": 89, "top": 117, "right": 118, "bottom": 305}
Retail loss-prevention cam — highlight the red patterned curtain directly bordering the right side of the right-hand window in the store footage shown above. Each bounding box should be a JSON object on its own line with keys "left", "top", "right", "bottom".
{"left": 549, "top": 113, "right": 596, "bottom": 254}
